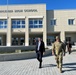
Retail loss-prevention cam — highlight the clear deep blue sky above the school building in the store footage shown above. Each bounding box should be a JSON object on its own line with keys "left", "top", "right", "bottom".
{"left": 0, "top": 0, "right": 76, "bottom": 10}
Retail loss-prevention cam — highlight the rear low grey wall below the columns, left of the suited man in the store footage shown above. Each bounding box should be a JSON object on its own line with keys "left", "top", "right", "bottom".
{"left": 0, "top": 46, "right": 35, "bottom": 52}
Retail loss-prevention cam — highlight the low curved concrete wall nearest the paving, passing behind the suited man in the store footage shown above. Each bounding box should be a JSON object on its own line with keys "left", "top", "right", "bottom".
{"left": 0, "top": 50, "right": 51, "bottom": 61}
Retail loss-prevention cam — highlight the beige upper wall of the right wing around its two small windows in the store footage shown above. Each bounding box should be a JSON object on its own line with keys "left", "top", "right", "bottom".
{"left": 47, "top": 10, "right": 76, "bottom": 32}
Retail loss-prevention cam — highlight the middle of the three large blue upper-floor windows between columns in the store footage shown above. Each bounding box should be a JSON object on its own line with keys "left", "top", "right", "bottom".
{"left": 12, "top": 19, "right": 25, "bottom": 28}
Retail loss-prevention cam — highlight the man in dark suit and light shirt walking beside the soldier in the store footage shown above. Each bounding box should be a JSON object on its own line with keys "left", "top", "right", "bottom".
{"left": 36, "top": 38, "right": 45, "bottom": 68}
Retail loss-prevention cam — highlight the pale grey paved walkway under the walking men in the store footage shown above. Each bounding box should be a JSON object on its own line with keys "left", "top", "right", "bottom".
{"left": 0, "top": 52, "right": 76, "bottom": 75}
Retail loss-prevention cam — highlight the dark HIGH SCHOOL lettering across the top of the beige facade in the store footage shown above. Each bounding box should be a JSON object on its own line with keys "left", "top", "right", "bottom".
{"left": 0, "top": 9, "right": 38, "bottom": 13}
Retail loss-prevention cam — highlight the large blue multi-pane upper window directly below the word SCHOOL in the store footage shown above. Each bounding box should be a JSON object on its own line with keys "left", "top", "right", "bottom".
{"left": 29, "top": 19, "right": 43, "bottom": 28}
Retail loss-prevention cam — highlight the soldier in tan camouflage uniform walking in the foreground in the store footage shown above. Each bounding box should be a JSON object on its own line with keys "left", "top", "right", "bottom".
{"left": 52, "top": 36, "right": 65, "bottom": 73}
